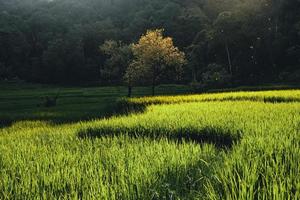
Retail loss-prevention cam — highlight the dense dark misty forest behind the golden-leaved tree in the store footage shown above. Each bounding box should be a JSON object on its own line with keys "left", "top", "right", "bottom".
{"left": 0, "top": 0, "right": 300, "bottom": 87}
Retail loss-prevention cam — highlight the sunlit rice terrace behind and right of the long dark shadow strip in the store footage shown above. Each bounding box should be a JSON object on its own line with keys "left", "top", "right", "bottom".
{"left": 80, "top": 101, "right": 300, "bottom": 199}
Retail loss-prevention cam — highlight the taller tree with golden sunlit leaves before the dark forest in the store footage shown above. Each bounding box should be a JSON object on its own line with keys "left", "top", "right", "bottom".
{"left": 125, "top": 29, "right": 186, "bottom": 96}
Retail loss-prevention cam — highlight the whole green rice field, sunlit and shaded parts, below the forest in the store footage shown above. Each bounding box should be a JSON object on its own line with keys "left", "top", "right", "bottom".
{"left": 0, "top": 82, "right": 300, "bottom": 200}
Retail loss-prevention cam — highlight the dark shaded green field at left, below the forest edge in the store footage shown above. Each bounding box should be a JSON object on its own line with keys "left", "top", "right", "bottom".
{"left": 0, "top": 83, "right": 189, "bottom": 126}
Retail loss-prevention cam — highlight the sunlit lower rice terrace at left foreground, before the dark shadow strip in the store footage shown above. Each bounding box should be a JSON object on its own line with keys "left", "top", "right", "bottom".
{"left": 0, "top": 122, "right": 219, "bottom": 199}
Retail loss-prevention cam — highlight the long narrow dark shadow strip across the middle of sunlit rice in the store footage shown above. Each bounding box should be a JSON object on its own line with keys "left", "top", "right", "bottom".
{"left": 77, "top": 126, "right": 242, "bottom": 149}
